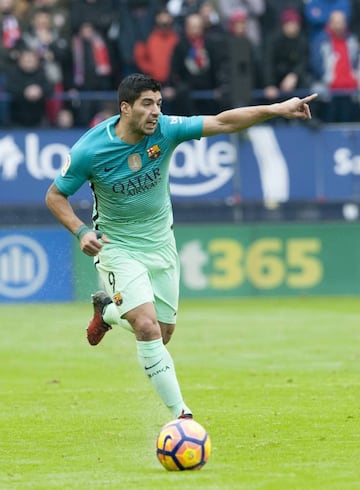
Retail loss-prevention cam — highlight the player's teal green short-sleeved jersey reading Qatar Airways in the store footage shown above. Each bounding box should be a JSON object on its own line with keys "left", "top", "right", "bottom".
{"left": 55, "top": 114, "right": 204, "bottom": 249}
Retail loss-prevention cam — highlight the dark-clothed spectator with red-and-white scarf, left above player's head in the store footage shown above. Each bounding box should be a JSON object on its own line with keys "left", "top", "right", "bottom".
{"left": 72, "top": 22, "right": 112, "bottom": 126}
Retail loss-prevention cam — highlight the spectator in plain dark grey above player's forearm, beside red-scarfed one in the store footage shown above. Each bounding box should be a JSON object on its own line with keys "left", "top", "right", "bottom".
{"left": 223, "top": 9, "right": 260, "bottom": 108}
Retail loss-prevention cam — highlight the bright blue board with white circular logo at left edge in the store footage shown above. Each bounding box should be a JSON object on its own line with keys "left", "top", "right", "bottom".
{"left": 0, "top": 228, "right": 73, "bottom": 303}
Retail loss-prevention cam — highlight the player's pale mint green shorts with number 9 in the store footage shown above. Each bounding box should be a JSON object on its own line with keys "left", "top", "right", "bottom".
{"left": 95, "top": 241, "right": 180, "bottom": 324}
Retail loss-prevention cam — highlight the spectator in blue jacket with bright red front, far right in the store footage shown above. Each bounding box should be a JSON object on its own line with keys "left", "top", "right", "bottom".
{"left": 311, "top": 10, "right": 360, "bottom": 122}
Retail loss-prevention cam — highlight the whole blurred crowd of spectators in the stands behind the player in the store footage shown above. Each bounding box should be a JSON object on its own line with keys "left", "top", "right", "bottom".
{"left": 0, "top": 0, "right": 360, "bottom": 128}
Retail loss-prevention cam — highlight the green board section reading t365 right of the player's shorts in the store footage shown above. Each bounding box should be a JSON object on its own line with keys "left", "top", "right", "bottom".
{"left": 177, "top": 224, "right": 360, "bottom": 297}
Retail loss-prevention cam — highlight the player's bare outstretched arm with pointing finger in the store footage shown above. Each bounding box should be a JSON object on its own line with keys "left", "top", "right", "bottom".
{"left": 202, "top": 94, "right": 317, "bottom": 136}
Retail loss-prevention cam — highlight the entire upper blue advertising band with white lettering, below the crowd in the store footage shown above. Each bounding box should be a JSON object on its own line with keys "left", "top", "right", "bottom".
{"left": 0, "top": 124, "right": 360, "bottom": 205}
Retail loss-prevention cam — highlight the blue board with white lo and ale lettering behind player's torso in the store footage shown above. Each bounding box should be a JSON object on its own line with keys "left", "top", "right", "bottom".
{"left": 0, "top": 130, "right": 237, "bottom": 204}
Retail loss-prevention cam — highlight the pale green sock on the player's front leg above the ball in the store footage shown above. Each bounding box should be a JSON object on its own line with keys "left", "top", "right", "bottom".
{"left": 136, "top": 339, "right": 191, "bottom": 418}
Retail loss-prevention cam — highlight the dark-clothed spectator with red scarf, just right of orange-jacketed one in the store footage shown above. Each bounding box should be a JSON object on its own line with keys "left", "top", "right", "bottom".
{"left": 171, "top": 14, "right": 224, "bottom": 115}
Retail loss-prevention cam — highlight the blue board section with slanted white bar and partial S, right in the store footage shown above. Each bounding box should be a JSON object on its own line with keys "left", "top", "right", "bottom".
{"left": 239, "top": 125, "right": 360, "bottom": 202}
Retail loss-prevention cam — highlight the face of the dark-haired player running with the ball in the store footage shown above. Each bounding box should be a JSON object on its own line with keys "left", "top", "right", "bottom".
{"left": 128, "top": 90, "right": 162, "bottom": 136}
